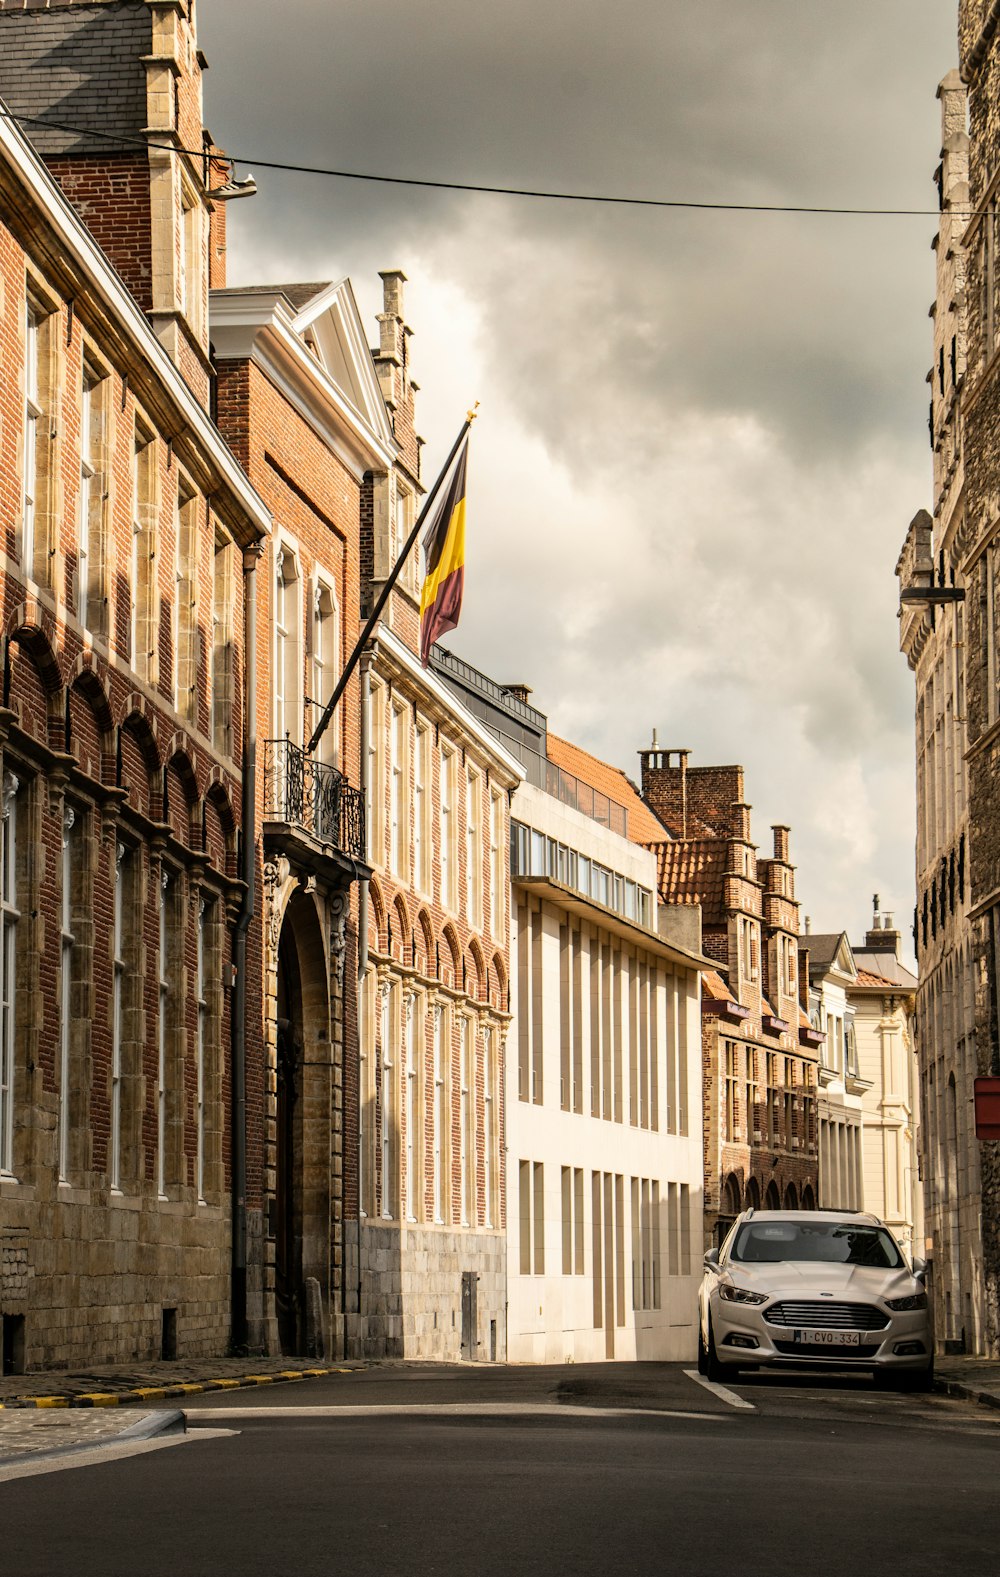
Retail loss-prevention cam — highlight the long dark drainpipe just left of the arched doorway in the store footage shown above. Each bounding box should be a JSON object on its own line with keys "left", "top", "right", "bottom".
{"left": 230, "top": 544, "right": 262, "bottom": 1351}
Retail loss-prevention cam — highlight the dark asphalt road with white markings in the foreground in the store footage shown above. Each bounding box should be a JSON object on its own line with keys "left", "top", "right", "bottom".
{"left": 0, "top": 1364, "right": 1000, "bottom": 1577}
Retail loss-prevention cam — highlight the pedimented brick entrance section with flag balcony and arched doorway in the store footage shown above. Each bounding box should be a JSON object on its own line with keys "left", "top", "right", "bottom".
{"left": 211, "top": 279, "right": 375, "bottom": 1356}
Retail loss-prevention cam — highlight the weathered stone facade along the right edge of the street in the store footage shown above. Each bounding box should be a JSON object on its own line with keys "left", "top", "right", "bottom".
{"left": 897, "top": 15, "right": 1000, "bottom": 1355}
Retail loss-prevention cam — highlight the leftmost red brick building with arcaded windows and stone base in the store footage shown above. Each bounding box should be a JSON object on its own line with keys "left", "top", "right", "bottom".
{"left": 0, "top": 21, "right": 270, "bottom": 1370}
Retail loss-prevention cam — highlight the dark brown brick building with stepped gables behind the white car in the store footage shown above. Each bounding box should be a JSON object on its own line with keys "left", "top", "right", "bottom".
{"left": 640, "top": 743, "right": 820, "bottom": 1243}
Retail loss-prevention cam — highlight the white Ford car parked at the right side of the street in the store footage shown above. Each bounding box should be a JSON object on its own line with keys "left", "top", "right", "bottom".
{"left": 699, "top": 1210, "right": 934, "bottom": 1391}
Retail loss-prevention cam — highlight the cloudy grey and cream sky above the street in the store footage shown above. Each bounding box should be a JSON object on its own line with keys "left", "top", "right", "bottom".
{"left": 199, "top": 0, "right": 956, "bottom": 940}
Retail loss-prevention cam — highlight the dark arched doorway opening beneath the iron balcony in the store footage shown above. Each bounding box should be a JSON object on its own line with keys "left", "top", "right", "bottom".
{"left": 274, "top": 893, "right": 333, "bottom": 1356}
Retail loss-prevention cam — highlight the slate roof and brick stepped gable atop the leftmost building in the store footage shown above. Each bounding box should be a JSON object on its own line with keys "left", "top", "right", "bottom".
{"left": 0, "top": 0, "right": 229, "bottom": 404}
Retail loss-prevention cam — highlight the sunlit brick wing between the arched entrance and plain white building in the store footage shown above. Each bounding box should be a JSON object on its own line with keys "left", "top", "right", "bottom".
{"left": 345, "top": 273, "right": 521, "bottom": 1358}
